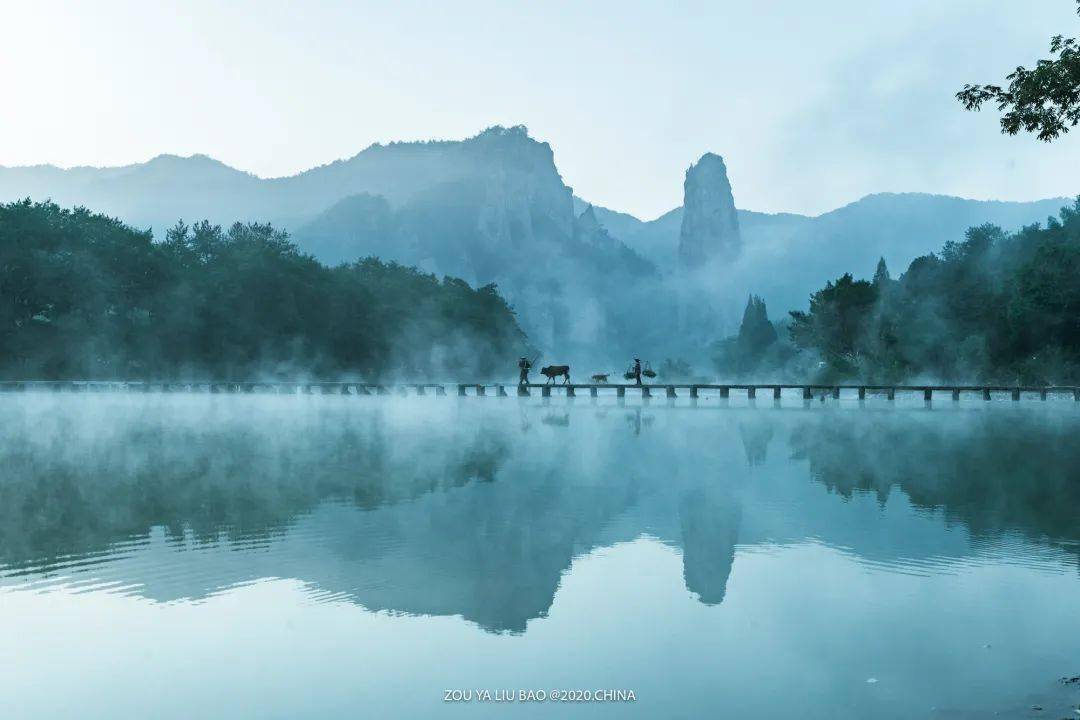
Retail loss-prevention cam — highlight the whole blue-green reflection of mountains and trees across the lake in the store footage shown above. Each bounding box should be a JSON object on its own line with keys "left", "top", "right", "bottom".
{"left": 0, "top": 396, "right": 1080, "bottom": 633}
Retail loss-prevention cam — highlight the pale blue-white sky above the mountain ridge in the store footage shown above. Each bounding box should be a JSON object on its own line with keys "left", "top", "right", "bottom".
{"left": 0, "top": 0, "right": 1080, "bottom": 218}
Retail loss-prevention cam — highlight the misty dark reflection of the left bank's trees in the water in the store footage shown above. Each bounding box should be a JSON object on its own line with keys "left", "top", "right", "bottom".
{"left": 0, "top": 408, "right": 509, "bottom": 566}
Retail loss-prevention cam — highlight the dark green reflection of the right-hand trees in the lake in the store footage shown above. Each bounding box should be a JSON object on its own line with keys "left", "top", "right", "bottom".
{"left": 792, "top": 411, "right": 1080, "bottom": 548}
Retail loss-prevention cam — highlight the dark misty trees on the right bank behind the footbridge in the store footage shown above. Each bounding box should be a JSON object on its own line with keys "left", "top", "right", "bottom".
{"left": 713, "top": 199, "right": 1080, "bottom": 385}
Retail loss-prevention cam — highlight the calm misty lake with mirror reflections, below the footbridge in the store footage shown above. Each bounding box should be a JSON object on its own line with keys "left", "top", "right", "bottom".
{"left": 0, "top": 393, "right": 1080, "bottom": 720}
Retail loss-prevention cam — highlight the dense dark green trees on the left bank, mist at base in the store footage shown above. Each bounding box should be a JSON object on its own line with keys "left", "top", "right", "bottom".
{"left": 0, "top": 200, "right": 529, "bottom": 380}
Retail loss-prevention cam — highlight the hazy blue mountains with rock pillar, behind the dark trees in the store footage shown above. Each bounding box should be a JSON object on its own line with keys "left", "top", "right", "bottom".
{"left": 0, "top": 126, "right": 1068, "bottom": 369}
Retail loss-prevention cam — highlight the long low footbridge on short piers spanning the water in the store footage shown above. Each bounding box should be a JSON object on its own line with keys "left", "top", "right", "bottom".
{"left": 0, "top": 380, "right": 1080, "bottom": 403}
